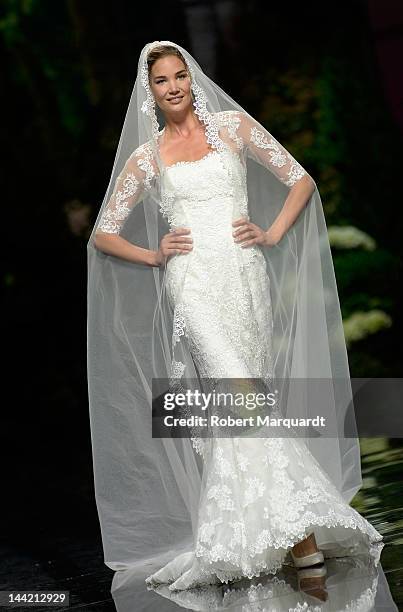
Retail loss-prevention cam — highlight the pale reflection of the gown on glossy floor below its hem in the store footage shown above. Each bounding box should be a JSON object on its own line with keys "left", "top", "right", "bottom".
{"left": 113, "top": 556, "right": 398, "bottom": 612}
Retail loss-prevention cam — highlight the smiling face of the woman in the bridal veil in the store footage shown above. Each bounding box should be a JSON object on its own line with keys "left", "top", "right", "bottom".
{"left": 150, "top": 55, "right": 192, "bottom": 113}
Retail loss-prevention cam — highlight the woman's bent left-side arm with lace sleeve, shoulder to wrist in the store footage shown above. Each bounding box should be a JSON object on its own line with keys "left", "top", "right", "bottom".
{"left": 94, "top": 145, "right": 162, "bottom": 266}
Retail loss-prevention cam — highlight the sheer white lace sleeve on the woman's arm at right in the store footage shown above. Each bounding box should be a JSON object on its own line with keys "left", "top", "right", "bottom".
{"left": 236, "top": 112, "right": 309, "bottom": 187}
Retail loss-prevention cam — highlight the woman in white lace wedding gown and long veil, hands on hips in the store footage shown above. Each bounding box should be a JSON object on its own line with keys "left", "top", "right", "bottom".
{"left": 88, "top": 41, "right": 383, "bottom": 590}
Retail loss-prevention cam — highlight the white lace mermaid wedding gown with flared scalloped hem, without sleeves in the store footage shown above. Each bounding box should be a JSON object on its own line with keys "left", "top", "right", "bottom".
{"left": 146, "top": 128, "right": 382, "bottom": 590}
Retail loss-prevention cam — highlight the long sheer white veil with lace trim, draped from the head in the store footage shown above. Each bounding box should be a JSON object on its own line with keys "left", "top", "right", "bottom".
{"left": 87, "top": 41, "right": 362, "bottom": 570}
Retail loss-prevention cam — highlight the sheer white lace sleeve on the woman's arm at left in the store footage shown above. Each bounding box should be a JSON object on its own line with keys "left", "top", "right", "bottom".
{"left": 96, "top": 143, "right": 155, "bottom": 234}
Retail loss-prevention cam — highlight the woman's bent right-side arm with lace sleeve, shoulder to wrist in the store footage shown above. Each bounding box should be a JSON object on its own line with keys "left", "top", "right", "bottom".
{"left": 238, "top": 113, "right": 316, "bottom": 246}
